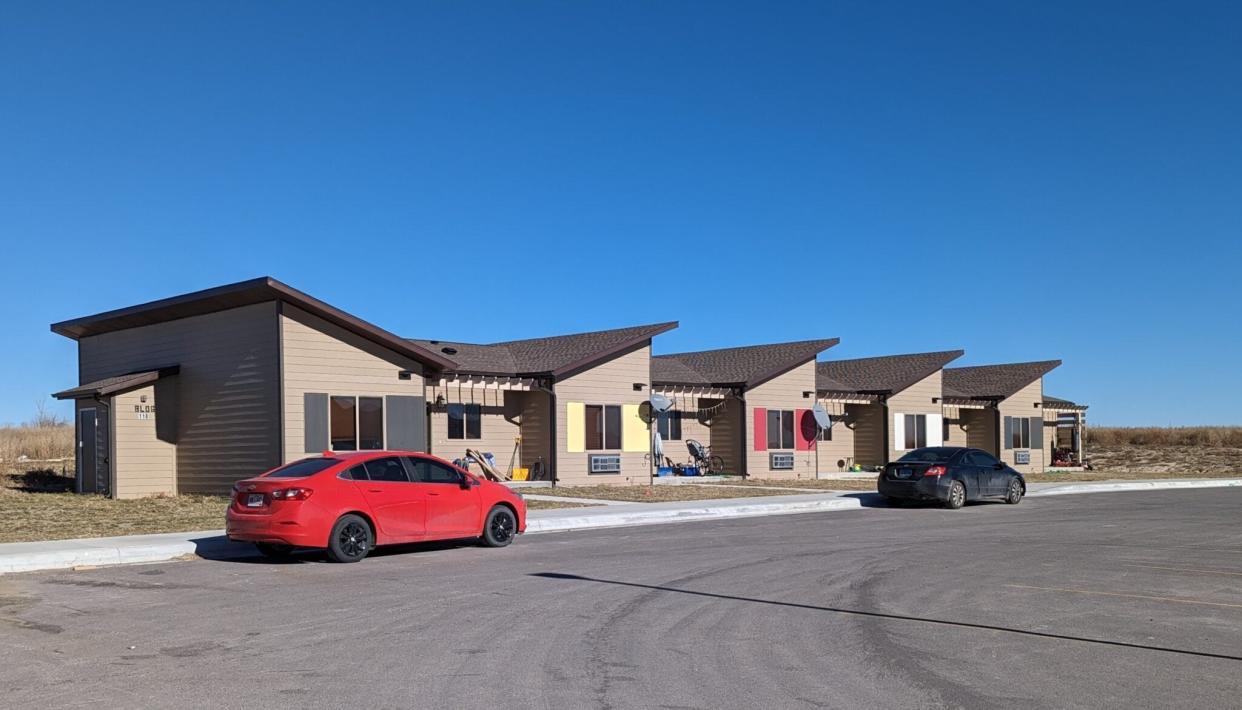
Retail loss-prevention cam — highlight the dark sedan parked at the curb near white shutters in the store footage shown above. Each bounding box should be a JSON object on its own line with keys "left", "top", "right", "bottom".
{"left": 876, "top": 446, "right": 1026, "bottom": 510}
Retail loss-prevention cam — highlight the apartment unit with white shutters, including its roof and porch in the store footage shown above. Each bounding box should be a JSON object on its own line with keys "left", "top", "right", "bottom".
{"left": 816, "top": 350, "right": 964, "bottom": 470}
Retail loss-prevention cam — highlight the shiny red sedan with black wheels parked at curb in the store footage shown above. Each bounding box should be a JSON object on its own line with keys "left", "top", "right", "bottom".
{"left": 225, "top": 452, "right": 527, "bottom": 562}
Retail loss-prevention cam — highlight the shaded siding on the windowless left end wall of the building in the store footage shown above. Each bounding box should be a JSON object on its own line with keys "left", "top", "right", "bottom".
{"left": 78, "top": 302, "right": 281, "bottom": 493}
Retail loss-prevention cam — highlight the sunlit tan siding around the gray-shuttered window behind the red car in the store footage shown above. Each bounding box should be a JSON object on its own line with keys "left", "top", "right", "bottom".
{"left": 279, "top": 304, "right": 424, "bottom": 461}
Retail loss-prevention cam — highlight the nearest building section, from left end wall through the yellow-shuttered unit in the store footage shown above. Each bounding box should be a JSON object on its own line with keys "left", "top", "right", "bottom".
{"left": 52, "top": 277, "right": 677, "bottom": 498}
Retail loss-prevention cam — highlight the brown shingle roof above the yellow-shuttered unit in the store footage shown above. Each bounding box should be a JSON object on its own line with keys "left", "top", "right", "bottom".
{"left": 411, "top": 321, "right": 677, "bottom": 376}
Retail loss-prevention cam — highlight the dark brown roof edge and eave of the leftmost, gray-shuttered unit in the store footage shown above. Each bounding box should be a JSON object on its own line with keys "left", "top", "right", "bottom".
{"left": 52, "top": 276, "right": 452, "bottom": 370}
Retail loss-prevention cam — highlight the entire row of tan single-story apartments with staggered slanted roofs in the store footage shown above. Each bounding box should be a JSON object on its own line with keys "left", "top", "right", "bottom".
{"left": 51, "top": 277, "right": 1087, "bottom": 498}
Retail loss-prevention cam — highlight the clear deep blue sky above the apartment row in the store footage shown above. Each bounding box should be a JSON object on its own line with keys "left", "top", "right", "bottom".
{"left": 0, "top": 1, "right": 1242, "bottom": 425}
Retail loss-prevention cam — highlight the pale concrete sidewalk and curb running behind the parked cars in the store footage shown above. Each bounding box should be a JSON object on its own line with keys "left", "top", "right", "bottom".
{"left": 0, "top": 478, "right": 1242, "bottom": 575}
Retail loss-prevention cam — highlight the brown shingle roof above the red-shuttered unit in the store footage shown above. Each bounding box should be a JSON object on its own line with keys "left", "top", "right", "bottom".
{"left": 651, "top": 338, "right": 841, "bottom": 387}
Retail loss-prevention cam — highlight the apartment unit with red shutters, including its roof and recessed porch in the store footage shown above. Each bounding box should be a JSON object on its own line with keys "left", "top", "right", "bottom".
{"left": 651, "top": 338, "right": 840, "bottom": 478}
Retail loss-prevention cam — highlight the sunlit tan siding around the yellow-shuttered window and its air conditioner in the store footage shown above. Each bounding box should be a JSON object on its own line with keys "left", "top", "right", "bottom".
{"left": 555, "top": 340, "right": 651, "bottom": 485}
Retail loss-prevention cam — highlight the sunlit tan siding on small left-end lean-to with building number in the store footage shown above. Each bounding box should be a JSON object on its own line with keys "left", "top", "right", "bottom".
{"left": 112, "top": 385, "right": 176, "bottom": 498}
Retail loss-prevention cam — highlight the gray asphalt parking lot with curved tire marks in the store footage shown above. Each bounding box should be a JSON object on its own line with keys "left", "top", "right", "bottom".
{"left": 0, "top": 489, "right": 1242, "bottom": 708}
